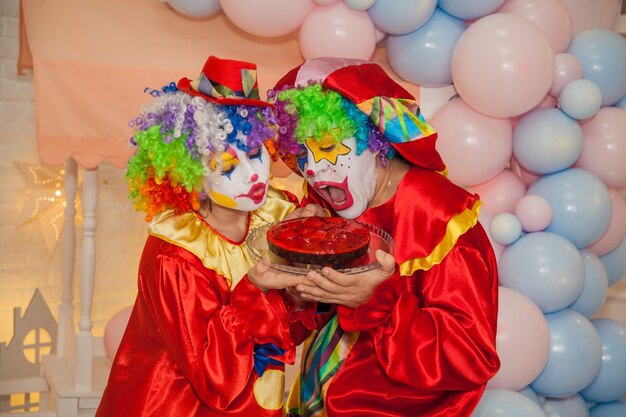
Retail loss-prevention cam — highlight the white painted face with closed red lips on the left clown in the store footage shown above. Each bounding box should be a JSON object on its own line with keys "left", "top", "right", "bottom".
{"left": 207, "top": 145, "right": 270, "bottom": 211}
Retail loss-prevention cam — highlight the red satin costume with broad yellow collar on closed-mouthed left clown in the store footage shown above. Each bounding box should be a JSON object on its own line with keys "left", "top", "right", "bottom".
{"left": 96, "top": 189, "right": 304, "bottom": 417}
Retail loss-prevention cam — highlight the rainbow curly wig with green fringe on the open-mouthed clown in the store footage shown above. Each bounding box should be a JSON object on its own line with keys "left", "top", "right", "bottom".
{"left": 267, "top": 84, "right": 396, "bottom": 171}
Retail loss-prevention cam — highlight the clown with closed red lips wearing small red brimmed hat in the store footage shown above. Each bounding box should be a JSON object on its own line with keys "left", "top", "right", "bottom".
{"left": 97, "top": 56, "right": 316, "bottom": 417}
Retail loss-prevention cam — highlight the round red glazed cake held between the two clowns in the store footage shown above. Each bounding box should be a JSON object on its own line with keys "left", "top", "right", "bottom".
{"left": 267, "top": 217, "right": 370, "bottom": 267}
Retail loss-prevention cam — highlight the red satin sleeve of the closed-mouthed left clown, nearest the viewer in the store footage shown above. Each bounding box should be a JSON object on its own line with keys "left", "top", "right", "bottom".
{"left": 140, "top": 238, "right": 295, "bottom": 410}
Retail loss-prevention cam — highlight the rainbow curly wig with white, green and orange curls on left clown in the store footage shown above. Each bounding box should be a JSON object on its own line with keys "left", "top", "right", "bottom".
{"left": 126, "top": 88, "right": 276, "bottom": 221}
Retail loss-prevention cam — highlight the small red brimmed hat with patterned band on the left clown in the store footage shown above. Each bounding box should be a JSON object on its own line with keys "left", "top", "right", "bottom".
{"left": 177, "top": 55, "right": 272, "bottom": 107}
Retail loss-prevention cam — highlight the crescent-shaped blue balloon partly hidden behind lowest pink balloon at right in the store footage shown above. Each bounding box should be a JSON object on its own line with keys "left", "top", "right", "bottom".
{"left": 530, "top": 308, "right": 602, "bottom": 398}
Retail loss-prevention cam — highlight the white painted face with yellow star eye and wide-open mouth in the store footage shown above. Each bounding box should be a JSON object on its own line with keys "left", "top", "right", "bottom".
{"left": 298, "top": 138, "right": 376, "bottom": 219}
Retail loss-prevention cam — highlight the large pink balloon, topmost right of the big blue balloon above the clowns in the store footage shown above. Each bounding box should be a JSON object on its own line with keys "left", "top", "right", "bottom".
{"left": 452, "top": 13, "right": 554, "bottom": 117}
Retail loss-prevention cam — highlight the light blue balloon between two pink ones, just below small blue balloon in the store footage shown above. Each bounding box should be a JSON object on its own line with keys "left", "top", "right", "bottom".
{"left": 513, "top": 109, "right": 584, "bottom": 174}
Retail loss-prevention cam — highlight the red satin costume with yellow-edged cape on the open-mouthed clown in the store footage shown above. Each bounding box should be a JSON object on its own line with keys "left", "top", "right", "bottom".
{"left": 287, "top": 167, "right": 499, "bottom": 417}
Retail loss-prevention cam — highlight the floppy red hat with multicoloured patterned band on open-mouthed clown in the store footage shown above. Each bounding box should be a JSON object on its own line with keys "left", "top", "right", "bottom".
{"left": 274, "top": 58, "right": 446, "bottom": 172}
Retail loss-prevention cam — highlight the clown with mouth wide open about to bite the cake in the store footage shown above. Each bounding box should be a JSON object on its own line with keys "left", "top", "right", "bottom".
{"left": 269, "top": 58, "right": 499, "bottom": 417}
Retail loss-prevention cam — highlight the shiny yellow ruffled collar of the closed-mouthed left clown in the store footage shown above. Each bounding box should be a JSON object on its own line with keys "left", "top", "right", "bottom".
{"left": 148, "top": 188, "right": 295, "bottom": 288}
